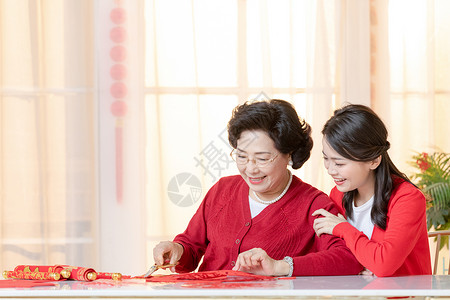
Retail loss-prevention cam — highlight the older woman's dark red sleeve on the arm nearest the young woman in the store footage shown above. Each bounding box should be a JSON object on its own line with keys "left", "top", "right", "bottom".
{"left": 293, "top": 195, "right": 363, "bottom": 276}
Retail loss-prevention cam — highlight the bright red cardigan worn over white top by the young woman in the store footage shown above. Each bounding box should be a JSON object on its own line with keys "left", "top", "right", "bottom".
{"left": 330, "top": 178, "right": 431, "bottom": 277}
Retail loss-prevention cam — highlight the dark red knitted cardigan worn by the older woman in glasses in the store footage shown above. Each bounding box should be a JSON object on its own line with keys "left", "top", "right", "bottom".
{"left": 174, "top": 175, "right": 362, "bottom": 276}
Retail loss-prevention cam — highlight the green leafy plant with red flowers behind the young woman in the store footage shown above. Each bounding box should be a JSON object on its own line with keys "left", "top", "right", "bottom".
{"left": 411, "top": 152, "right": 450, "bottom": 248}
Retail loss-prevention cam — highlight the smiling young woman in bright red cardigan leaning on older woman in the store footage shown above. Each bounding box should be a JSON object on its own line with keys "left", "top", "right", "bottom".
{"left": 313, "top": 105, "right": 431, "bottom": 276}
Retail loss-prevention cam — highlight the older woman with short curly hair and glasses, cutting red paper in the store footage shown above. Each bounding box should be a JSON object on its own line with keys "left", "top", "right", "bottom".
{"left": 153, "top": 100, "right": 362, "bottom": 276}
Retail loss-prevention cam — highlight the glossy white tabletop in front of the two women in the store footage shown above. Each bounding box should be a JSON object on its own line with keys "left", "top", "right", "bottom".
{"left": 0, "top": 275, "right": 450, "bottom": 299}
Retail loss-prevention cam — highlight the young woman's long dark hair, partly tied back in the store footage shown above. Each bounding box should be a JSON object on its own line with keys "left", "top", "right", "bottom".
{"left": 322, "top": 104, "right": 410, "bottom": 230}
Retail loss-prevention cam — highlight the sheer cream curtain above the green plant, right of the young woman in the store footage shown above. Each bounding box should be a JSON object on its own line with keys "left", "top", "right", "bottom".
{"left": 371, "top": 0, "right": 450, "bottom": 174}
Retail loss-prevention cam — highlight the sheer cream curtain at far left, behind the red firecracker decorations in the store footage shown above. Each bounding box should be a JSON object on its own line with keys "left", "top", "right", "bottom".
{"left": 0, "top": 0, "right": 98, "bottom": 270}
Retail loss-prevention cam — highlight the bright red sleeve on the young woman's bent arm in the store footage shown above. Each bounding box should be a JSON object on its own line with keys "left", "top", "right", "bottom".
{"left": 333, "top": 182, "right": 426, "bottom": 277}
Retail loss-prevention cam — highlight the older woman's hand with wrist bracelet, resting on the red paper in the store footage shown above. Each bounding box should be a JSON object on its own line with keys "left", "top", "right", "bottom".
{"left": 233, "top": 248, "right": 290, "bottom": 276}
